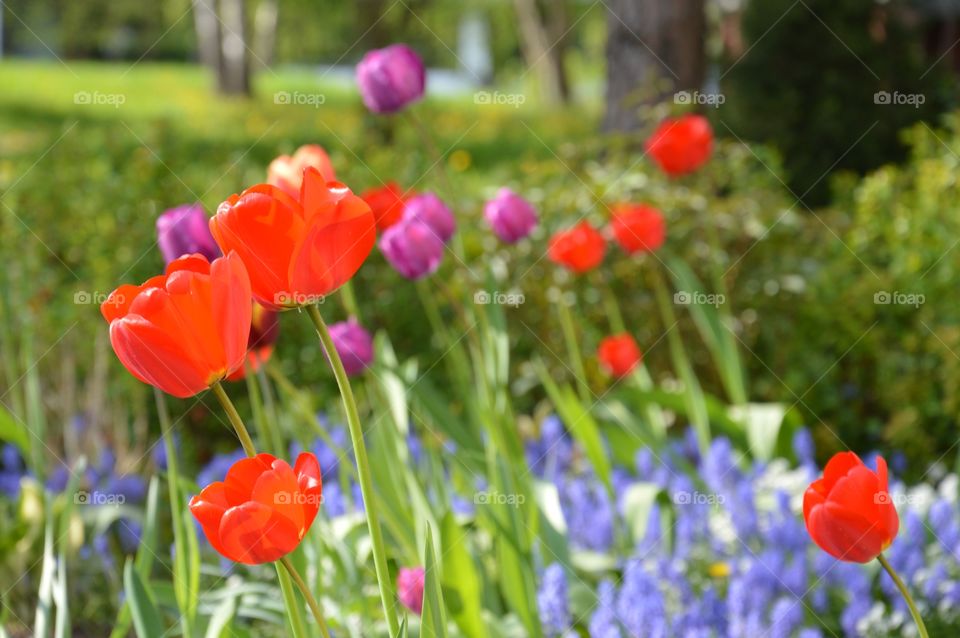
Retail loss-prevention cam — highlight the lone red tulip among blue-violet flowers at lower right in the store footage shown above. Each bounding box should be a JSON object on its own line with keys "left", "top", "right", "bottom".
{"left": 803, "top": 452, "right": 900, "bottom": 563}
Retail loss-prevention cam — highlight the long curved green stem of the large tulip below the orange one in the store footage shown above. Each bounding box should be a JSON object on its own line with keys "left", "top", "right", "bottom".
{"left": 306, "top": 306, "right": 400, "bottom": 636}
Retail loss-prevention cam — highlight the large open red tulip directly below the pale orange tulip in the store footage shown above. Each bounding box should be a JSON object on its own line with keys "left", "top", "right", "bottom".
{"left": 210, "top": 167, "right": 376, "bottom": 309}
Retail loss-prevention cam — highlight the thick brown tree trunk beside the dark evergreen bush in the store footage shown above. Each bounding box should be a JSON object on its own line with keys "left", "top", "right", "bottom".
{"left": 604, "top": 0, "right": 706, "bottom": 131}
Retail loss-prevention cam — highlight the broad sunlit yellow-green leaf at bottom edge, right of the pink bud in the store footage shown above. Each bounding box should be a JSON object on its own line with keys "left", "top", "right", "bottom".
{"left": 440, "top": 512, "right": 487, "bottom": 638}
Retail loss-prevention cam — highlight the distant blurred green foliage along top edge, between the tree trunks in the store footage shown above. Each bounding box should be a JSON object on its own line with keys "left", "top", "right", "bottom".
{"left": 4, "top": 0, "right": 604, "bottom": 69}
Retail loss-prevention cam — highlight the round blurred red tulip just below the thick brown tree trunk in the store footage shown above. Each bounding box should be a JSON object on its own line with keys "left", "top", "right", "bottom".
{"left": 646, "top": 115, "right": 713, "bottom": 177}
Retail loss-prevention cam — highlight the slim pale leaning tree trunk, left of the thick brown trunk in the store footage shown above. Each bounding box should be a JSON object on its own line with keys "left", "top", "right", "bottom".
{"left": 514, "top": 0, "right": 569, "bottom": 104}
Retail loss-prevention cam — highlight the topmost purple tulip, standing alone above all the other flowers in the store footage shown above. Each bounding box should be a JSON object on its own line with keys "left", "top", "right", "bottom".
{"left": 357, "top": 44, "right": 426, "bottom": 114}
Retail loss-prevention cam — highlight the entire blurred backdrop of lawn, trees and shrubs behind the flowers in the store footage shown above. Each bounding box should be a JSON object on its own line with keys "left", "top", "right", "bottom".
{"left": 0, "top": 0, "right": 960, "bottom": 635}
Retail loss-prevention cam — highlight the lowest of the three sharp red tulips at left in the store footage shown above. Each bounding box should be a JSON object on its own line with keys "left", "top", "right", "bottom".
{"left": 190, "top": 452, "right": 322, "bottom": 565}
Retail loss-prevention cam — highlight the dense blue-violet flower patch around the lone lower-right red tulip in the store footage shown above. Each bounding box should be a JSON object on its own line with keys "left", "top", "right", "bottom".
{"left": 526, "top": 417, "right": 960, "bottom": 638}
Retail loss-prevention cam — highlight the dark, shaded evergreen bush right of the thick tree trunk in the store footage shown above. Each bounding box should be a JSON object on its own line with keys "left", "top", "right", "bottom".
{"left": 719, "top": 0, "right": 955, "bottom": 206}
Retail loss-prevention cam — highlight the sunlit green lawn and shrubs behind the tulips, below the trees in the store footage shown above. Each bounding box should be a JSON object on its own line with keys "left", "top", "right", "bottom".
{"left": 0, "top": 64, "right": 960, "bottom": 482}
